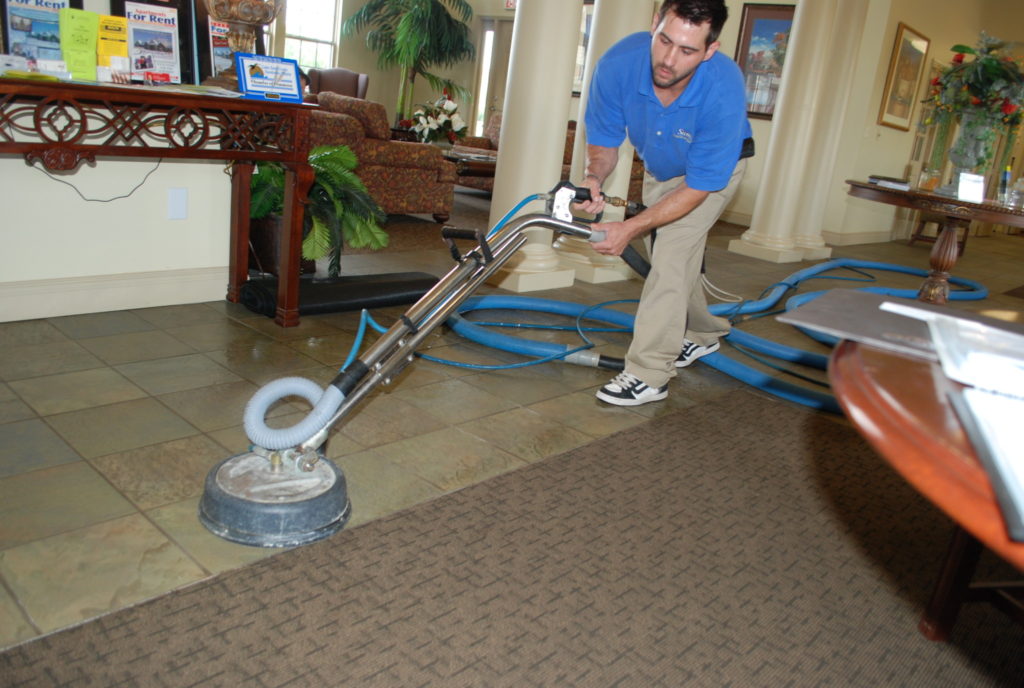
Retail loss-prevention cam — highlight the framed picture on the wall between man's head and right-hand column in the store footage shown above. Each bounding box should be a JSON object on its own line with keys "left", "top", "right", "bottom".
{"left": 736, "top": 3, "right": 797, "bottom": 120}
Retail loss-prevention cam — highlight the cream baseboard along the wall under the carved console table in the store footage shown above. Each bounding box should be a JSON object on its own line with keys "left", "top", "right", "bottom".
{"left": 0, "top": 267, "right": 227, "bottom": 323}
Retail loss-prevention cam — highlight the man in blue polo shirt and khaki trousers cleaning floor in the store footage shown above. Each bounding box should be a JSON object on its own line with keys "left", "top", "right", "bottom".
{"left": 580, "top": 0, "right": 754, "bottom": 406}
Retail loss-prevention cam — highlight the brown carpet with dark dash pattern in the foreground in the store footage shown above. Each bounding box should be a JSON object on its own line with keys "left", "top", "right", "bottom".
{"left": 0, "top": 390, "right": 1024, "bottom": 688}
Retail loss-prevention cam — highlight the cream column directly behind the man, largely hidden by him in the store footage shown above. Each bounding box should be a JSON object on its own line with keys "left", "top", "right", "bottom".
{"left": 555, "top": 0, "right": 653, "bottom": 284}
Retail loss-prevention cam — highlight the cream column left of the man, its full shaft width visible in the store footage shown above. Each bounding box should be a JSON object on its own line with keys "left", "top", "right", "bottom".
{"left": 488, "top": 0, "right": 583, "bottom": 292}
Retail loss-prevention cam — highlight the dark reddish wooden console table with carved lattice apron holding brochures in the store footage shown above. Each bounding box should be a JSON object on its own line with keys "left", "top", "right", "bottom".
{"left": 0, "top": 79, "right": 313, "bottom": 328}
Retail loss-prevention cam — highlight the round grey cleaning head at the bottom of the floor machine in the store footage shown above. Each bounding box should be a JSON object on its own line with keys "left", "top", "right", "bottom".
{"left": 199, "top": 452, "right": 351, "bottom": 547}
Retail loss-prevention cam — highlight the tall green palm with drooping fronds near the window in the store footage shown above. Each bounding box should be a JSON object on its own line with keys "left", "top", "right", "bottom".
{"left": 341, "top": 0, "right": 476, "bottom": 122}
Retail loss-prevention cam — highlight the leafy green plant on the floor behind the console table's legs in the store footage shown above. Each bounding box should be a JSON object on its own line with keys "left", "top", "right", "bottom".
{"left": 249, "top": 145, "right": 388, "bottom": 276}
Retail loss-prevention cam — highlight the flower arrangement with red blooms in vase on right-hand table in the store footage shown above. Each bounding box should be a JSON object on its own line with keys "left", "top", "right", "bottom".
{"left": 930, "top": 32, "right": 1024, "bottom": 130}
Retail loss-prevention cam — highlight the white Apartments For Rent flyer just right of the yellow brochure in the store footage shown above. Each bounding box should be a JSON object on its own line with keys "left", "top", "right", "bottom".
{"left": 125, "top": 2, "right": 181, "bottom": 84}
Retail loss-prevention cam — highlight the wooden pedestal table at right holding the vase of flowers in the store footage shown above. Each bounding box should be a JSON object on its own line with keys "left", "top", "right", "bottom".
{"left": 846, "top": 179, "right": 1024, "bottom": 303}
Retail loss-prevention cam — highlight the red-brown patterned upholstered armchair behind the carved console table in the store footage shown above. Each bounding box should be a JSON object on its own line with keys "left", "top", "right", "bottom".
{"left": 309, "top": 91, "right": 455, "bottom": 222}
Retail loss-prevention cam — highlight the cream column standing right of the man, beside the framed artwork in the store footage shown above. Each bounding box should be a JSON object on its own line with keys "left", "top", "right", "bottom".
{"left": 729, "top": 0, "right": 869, "bottom": 263}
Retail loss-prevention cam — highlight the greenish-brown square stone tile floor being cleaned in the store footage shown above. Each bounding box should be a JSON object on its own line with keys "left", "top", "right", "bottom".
{"left": 0, "top": 193, "right": 1024, "bottom": 647}
